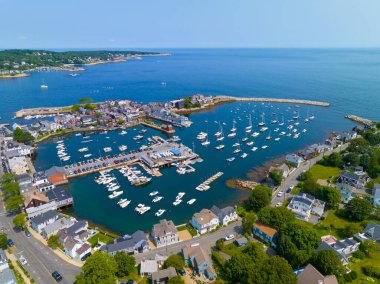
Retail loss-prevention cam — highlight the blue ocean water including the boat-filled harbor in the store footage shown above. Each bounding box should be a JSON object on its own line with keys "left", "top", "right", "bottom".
{"left": 0, "top": 49, "right": 380, "bottom": 233}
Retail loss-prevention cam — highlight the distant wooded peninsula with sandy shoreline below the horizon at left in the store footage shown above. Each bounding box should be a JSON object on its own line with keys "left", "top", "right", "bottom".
{"left": 0, "top": 49, "right": 168, "bottom": 78}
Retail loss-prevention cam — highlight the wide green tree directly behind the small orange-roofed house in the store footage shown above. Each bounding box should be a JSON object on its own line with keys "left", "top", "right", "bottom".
{"left": 258, "top": 206, "right": 296, "bottom": 230}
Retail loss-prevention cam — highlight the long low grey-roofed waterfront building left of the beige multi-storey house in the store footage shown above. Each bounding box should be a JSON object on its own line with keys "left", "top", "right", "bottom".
{"left": 101, "top": 231, "right": 149, "bottom": 255}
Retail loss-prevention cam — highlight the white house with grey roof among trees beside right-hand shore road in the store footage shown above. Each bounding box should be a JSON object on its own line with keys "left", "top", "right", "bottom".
{"left": 287, "top": 193, "right": 325, "bottom": 221}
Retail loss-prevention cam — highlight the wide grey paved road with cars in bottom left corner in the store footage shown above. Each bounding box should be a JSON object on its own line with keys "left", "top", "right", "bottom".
{"left": 0, "top": 202, "right": 80, "bottom": 284}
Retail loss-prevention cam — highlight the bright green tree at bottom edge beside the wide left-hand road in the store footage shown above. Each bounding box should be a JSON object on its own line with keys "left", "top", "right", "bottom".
{"left": 75, "top": 251, "right": 117, "bottom": 284}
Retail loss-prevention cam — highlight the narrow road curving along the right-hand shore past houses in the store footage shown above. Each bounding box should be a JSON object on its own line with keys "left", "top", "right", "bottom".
{"left": 272, "top": 143, "right": 349, "bottom": 206}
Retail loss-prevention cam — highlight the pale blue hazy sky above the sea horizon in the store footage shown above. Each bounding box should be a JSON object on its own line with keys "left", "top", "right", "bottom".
{"left": 0, "top": 0, "right": 380, "bottom": 48}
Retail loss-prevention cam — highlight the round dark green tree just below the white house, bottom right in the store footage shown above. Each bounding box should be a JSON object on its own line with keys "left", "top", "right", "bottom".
{"left": 312, "top": 249, "right": 345, "bottom": 277}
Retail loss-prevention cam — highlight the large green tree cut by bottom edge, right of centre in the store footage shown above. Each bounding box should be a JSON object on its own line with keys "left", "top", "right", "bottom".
{"left": 250, "top": 256, "right": 297, "bottom": 284}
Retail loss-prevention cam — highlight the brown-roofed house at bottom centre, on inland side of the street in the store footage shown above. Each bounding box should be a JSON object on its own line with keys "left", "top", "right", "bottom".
{"left": 182, "top": 245, "right": 216, "bottom": 280}
